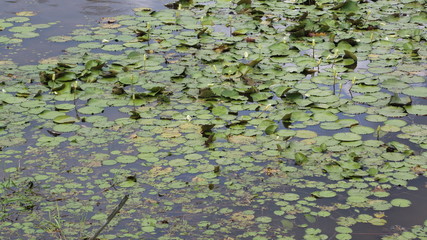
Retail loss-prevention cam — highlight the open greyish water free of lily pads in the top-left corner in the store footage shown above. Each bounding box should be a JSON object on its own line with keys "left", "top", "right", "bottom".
{"left": 0, "top": 0, "right": 171, "bottom": 64}
